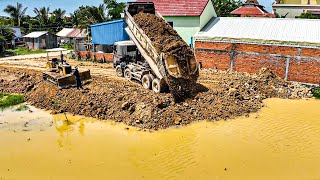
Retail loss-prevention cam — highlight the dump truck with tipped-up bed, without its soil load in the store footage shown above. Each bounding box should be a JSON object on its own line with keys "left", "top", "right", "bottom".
{"left": 113, "top": 2, "right": 199, "bottom": 93}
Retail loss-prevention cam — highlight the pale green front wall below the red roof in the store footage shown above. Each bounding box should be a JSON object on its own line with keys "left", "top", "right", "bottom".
{"left": 163, "top": 16, "right": 200, "bottom": 44}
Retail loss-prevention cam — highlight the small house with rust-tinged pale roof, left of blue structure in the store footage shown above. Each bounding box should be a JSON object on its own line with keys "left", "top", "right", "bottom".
{"left": 56, "top": 28, "right": 87, "bottom": 43}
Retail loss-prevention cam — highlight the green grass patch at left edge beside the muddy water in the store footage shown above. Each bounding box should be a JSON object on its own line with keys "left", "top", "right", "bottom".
{"left": 0, "top": 93, "right": 25, "bottom": 110}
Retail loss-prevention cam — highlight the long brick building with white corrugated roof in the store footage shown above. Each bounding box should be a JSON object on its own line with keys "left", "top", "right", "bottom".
{"left": 194, "top": 17, "right": 320, "bottom": 84}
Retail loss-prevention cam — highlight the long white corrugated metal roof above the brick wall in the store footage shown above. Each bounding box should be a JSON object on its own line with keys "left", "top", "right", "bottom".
{"left": 194, "top": 17, "right": 320, "bottom": 45}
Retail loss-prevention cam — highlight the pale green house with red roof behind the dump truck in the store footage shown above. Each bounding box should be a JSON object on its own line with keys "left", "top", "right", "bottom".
{"left": 137, "top": 0, "right": 217, "bottom": 44}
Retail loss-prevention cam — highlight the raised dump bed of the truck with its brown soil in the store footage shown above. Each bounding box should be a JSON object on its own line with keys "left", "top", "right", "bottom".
{"left": 125, "top": 2, "right": 199, "bottom": 97}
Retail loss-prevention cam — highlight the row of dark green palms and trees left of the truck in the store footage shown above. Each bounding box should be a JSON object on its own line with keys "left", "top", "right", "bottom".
{"left": 0, "top": 0, "right": 125, "bottom": 33}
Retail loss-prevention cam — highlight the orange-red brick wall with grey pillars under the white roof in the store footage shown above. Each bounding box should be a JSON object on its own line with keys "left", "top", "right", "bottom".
{"left": 195, "top": 41, "right": 320, "bottom": 84}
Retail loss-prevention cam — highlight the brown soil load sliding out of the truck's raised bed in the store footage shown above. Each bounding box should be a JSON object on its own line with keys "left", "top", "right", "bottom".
{"left": 133, "top": 13, "right": 198, "bottom": 102}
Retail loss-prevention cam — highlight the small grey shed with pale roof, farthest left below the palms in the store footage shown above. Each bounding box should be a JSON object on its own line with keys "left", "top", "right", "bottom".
{"left": 23, "top": 31, "right": 58, "bottom": 49}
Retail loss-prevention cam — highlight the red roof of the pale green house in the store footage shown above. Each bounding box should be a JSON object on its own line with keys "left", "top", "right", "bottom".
{"left": 137, "top": 0, "right": 209, "bottom": 16}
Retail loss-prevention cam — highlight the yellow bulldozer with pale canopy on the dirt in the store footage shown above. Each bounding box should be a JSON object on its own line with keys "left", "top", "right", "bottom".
{"left": 42, "top": 48, "right": 91, "bottom": 88}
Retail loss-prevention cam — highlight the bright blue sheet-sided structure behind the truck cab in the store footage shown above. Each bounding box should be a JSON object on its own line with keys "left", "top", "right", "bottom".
{"left": 91, "top": 20, "right": 129, "bottom": 45}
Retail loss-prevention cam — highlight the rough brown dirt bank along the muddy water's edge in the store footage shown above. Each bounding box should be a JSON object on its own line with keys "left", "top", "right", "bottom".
{"left": 0, "top": 66, "right": 310, "bottom": 129}
